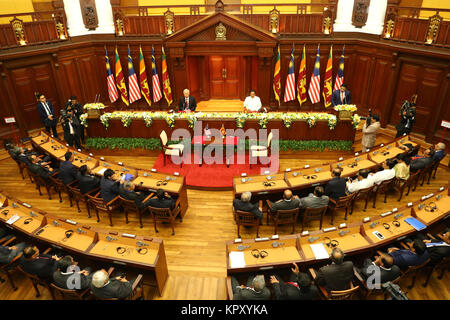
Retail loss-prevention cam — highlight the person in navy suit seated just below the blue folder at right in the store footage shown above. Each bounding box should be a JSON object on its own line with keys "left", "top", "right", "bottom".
{"left": 388, "top": 239, "right": 430, "bottom": 269}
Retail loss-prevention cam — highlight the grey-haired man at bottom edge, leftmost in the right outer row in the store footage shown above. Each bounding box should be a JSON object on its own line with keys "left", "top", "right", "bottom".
{"left": 231, "top": 275, "right": 270, "bottom": 300}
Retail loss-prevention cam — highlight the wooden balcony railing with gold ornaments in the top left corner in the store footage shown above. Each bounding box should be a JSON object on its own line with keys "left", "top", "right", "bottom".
{"left": 0, "top": 9, "right": 68, "bottom": 49}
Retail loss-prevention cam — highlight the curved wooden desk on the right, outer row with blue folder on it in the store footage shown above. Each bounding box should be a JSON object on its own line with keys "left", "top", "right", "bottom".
{"left": 226, "top": 185, "right": 450, "bottom": 297}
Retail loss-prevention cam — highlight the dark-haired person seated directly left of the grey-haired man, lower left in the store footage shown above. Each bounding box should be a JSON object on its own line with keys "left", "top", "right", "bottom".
{"left": 53, "top": 256, "right": 92, "bottom": 290}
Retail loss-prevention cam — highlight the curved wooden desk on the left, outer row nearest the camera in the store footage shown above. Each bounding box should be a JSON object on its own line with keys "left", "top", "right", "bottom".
{"left": 0, "top": 191, "right": 168, "bottom": 296}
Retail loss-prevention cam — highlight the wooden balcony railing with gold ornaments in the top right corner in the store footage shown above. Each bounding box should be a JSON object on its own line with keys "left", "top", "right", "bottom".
{"left": 382, "top": 5, "right": 450, "bottom": 48}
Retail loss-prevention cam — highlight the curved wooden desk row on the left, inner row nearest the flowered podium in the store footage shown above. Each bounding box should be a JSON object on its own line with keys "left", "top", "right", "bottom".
{"left": 31, "top": 132, "right": 188, "bottom": 218}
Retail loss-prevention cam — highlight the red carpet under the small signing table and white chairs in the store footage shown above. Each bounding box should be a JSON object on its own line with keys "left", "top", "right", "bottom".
{"left": 153, "top": 154, "right": 279, "bottom": 188}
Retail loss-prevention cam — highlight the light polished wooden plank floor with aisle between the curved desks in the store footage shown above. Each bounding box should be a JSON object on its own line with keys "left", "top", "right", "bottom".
{"left": 0, "top": 128, "right": 450, "bottom": 300}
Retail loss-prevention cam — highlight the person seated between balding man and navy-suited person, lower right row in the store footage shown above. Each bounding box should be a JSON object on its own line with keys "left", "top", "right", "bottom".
{"left": 359, "top": 253, "right": 401, "bottom": 284}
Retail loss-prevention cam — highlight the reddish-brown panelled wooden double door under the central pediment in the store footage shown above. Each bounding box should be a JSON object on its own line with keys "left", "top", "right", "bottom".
{"left": 209, "top": 56, "right": 243, "bottom": 99}
